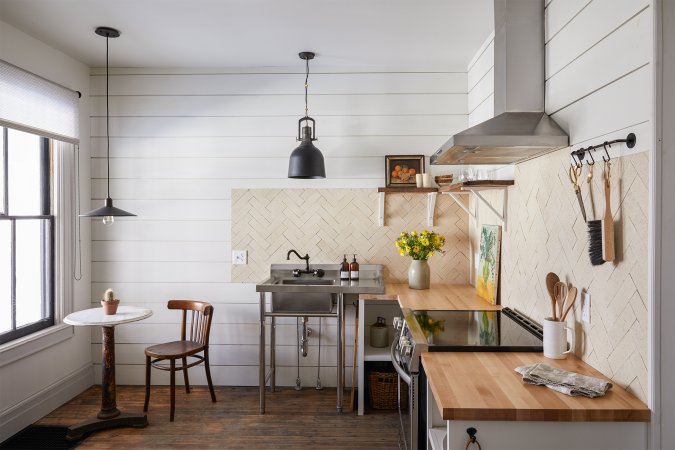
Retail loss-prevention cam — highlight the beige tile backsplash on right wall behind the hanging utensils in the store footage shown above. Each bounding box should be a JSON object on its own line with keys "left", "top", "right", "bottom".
{"left": 471, "top": 150, "right": 649, "bottom": 401}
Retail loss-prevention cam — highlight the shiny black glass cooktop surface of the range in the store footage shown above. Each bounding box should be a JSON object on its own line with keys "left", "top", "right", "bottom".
{"left": 413, "top": 307, "right": 543, "bottom": 352}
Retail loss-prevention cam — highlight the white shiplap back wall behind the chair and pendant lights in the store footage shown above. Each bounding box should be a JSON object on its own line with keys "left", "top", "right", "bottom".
{"left": 91, "top": 67, "right": 468, "bottom": 386}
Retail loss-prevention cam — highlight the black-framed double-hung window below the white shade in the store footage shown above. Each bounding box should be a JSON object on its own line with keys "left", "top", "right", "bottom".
{"left": 0, "top": 127, "right": 55, "bottom": 344}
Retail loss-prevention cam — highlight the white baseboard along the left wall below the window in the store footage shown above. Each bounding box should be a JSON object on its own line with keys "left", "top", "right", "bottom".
{"left": 0, "top": 364, "right": 94, "bottom": 442}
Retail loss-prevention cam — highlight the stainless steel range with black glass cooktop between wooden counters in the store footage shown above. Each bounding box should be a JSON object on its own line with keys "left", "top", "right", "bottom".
{"left": 391, "top": 308, "right": 542, "bottom": 450}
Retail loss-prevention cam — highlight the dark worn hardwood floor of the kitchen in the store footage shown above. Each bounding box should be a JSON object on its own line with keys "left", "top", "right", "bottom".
{"left": 37, "top": 386, "right": 399, "bottom": 450}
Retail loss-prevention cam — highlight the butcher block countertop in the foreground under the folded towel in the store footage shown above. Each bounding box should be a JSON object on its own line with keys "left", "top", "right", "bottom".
{"left": 422, "top": 352, "right": 650, "bottom": 422}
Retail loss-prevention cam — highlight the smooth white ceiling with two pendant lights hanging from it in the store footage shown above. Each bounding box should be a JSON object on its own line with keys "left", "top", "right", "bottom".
{"left": 0, "top": 0, "right": 493, "bottom": 71}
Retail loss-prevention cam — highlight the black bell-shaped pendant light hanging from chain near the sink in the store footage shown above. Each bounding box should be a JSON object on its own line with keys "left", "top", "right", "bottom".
{"left": 288, "top": 52, "right": 326, "bottom": 178}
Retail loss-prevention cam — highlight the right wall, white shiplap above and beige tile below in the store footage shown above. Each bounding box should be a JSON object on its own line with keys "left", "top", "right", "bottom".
{"left": 474, "top": 0, "right": 653, "bottom": 401}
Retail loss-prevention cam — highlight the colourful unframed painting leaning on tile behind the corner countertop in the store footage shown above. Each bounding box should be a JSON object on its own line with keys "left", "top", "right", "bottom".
{"left": 476, "top": 225, "right": 502, "bottom": 305}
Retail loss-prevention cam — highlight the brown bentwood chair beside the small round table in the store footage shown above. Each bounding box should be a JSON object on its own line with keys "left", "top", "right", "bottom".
{"left": 143, "top": 300, "right": 216, "bottom": 422}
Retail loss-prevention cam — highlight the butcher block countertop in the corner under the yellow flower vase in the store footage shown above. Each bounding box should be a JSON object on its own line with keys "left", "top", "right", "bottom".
{"left": 359, "top": 283, "right": 502, "bottom": 311}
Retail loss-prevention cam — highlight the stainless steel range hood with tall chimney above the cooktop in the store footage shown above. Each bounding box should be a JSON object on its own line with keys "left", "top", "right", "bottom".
{"left": 431, "top": 0, "right": 569, "bottom": 164}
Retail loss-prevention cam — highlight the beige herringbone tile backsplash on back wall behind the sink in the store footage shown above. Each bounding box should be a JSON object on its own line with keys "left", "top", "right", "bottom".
{"left": 232, "top": 189, "right": 469, "bottom": 283}
